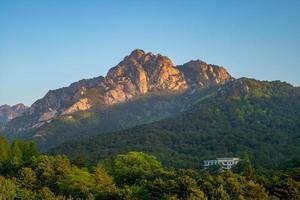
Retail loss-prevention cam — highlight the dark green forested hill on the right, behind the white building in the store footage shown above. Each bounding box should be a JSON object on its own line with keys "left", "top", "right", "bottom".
{"left": 49, "top": 78, "right": 300, "bottom": 169}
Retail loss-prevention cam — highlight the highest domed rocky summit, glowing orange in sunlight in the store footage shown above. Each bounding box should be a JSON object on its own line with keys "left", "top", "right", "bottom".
{"left": 104, "top": 50, "right": 187, "bottom": 104}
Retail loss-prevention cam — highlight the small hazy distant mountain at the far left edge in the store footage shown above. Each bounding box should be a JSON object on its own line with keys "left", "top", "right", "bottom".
{"left": 0, "top": 103, "right": 28, "bottom": 129}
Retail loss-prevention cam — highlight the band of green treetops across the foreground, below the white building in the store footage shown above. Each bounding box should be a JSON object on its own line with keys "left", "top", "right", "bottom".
{"left": 0, "top": 137, "right": 300, "bottom": 200}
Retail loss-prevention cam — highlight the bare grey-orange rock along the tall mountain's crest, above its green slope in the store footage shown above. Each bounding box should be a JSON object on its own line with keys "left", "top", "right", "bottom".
{"left": 4, "top": 49, "right": 232, "bottom": 130}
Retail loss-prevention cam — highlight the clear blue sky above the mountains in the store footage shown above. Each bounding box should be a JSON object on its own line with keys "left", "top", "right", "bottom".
{"left": 0, "top": 0, "right": 300, "bottom": 105}
